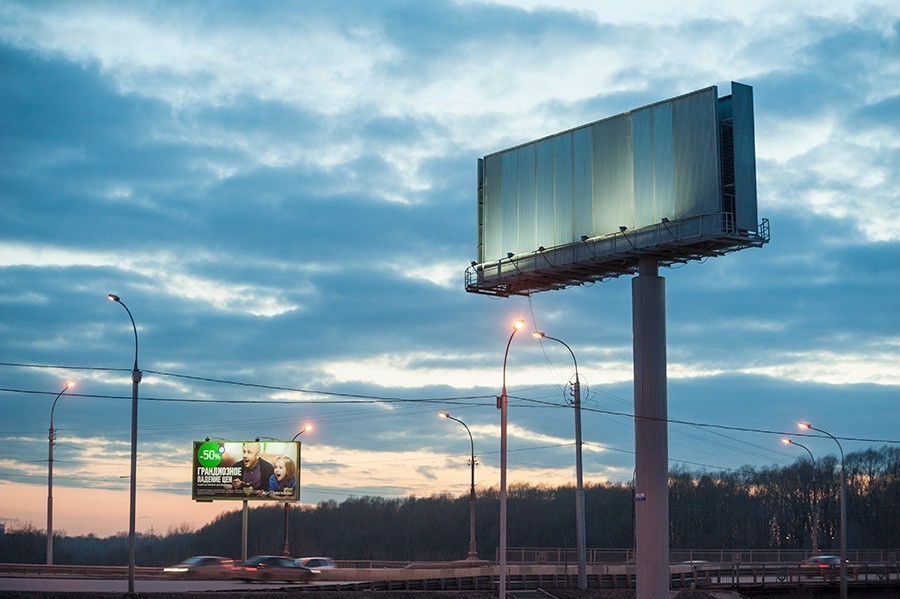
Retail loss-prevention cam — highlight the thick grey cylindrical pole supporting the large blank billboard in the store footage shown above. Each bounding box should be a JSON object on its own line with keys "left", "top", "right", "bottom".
{"left": 631, "top": 257, "right": 669, "bottom": 599}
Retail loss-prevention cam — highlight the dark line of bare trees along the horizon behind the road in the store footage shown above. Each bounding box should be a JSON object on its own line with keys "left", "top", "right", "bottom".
{"left": 0, "top": 446, "right": 900, "bottom": 566}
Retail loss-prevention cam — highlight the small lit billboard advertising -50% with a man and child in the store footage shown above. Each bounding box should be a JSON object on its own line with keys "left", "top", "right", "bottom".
{"left": 191, "top": 441, "right": 300, "bottom": 501}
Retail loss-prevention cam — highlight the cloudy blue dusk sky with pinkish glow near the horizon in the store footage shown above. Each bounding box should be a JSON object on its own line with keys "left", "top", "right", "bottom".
{"left": 0, "top": 0, "right": 900, "bottom": 542}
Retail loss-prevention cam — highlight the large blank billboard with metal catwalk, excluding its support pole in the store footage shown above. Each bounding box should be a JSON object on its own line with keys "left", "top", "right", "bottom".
{"left": 466, "top": 83, "right": 768, "bottom": 296}
